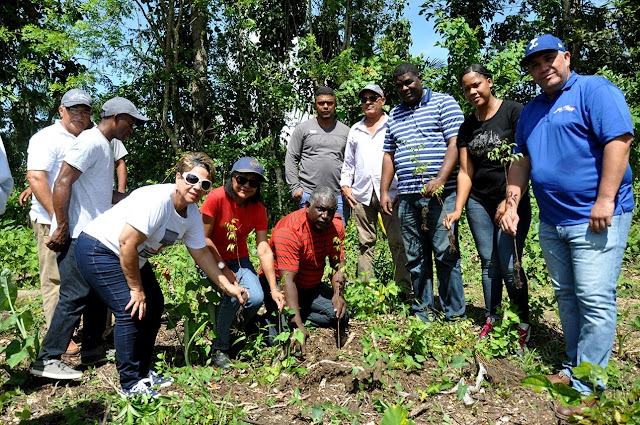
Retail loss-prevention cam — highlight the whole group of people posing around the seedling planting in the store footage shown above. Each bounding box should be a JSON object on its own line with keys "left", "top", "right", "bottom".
{"left": 7, "top": 34, "right": 635, "bottom": 419}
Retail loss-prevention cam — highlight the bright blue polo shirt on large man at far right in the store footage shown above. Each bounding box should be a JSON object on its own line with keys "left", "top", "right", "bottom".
{"left": 516, "top": 72, "right": 634, "bottom": 226}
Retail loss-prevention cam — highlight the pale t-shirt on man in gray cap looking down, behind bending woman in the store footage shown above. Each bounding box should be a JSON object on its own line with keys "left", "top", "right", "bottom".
{"left": 51, "top": 127, "right": 114, "bottom": 239}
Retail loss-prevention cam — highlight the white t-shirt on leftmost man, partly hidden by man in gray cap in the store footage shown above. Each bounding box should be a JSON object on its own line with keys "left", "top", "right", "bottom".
{"left": 27, "top": 120, "right": 76, "bottom": 224}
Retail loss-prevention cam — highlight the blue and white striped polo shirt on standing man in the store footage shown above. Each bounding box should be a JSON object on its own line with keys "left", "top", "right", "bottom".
{"left": 383, "top": 87, "right": 464, "bottom": 195}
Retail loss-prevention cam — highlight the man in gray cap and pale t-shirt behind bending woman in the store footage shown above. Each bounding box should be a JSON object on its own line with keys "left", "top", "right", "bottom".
{"left": 31, "top": 97, "right": 149, "bottom": 379}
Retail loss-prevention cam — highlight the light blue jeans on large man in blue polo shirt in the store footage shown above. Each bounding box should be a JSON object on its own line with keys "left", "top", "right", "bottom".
{"left": 540, "top": 212, "right": 633, "bottom": 394}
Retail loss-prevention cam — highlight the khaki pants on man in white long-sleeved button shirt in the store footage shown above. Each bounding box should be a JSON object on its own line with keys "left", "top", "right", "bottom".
{"left": 353, "top": 192, "right": 411, "bottom": 293}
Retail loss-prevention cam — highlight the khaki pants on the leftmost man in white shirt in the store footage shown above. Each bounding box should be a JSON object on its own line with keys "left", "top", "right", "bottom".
{"left": 31, "top": 221, "right": 60, "bottom": 328}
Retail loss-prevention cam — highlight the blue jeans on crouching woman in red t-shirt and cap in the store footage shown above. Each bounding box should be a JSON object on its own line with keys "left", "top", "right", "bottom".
{"left": 209, "top": 257, "right": 264, "bottom": 351}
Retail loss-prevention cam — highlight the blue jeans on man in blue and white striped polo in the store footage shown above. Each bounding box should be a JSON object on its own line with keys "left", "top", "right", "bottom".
{"left": 398, "top": 192, "right": 466, "bottom": 322}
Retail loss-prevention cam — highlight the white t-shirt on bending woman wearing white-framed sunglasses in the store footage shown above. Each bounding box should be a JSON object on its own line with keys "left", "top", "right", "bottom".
{"left": 84, "top": 184, "right": 207, "bottom": 267}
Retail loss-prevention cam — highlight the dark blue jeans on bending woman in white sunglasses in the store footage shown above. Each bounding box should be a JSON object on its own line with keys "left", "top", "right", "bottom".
{"left": 76, "top": 233, "right": 164, "bottom": 390}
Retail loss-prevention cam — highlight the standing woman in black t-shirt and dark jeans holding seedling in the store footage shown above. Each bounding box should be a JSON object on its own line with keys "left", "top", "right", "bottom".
{"left": 444, "top": 64, "right": 531, "bottom": 352}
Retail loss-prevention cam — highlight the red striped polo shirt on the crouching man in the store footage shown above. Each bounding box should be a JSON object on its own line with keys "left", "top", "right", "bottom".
{"left": 269, "top": 208, "right": 344, "bottom": 289}
